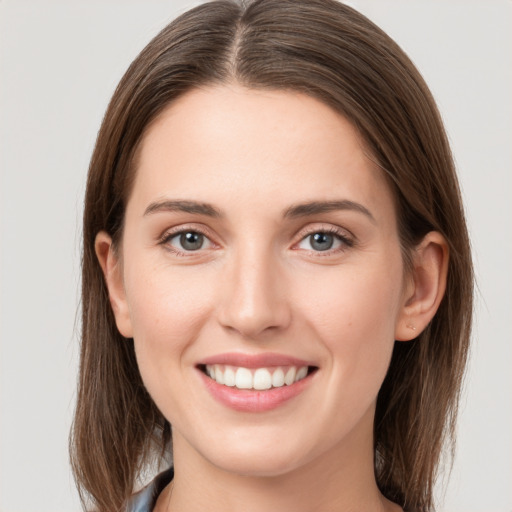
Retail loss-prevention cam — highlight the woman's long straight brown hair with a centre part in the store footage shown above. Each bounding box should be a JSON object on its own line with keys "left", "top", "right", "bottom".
{"left": 71, "top": 0, "right": 473, "bottom": 512}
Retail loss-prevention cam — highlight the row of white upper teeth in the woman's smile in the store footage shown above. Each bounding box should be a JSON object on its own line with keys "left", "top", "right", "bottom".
{"left": 206, "top": 364, "right": 308, "bottom": 390}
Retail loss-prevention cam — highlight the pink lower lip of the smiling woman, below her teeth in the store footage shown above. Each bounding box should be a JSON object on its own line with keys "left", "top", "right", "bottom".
{"left": 198, "top": 370, "right": 312, "bottom": 412}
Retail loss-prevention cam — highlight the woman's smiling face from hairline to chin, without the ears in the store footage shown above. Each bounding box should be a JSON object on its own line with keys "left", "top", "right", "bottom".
{"left": 106, "top": 85, "right": 414, "bottom": 475}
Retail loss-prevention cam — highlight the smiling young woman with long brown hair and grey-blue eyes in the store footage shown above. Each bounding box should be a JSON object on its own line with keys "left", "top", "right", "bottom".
{"left": 72, "top": 0, "right": 472, "bottom": 512}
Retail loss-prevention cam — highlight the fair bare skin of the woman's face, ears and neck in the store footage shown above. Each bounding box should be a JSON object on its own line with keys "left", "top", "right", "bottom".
{"left": 96, "top": 84, "right": 448, "bottom": 512}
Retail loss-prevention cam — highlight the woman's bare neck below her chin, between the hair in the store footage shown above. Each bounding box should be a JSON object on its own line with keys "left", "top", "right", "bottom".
{"left": 162, "top": 410, "right": 401, "bottom": 512}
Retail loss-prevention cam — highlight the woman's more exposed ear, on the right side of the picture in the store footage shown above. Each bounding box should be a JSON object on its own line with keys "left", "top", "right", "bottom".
{"left": 395, "top": 231, "right": 449, "bottom": 341}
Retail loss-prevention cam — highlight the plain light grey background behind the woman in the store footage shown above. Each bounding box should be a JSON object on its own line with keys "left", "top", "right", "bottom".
{"left": 0, "top": 0, "right": 512, "bottom": 512}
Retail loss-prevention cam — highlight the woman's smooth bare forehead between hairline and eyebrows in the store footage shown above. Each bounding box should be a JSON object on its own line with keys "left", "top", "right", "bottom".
{"left": 130, "top": 85, "right": 390, "bottom": 220}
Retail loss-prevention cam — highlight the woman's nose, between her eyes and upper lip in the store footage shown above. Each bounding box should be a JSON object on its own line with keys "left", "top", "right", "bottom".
{"left": 218, "top": 248, "right": 291, "bottom": 339}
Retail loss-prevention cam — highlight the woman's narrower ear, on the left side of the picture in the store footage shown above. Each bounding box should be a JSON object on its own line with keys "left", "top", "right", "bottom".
{"left": 94, "top": 231, "right": 133, "bottom": 338}
